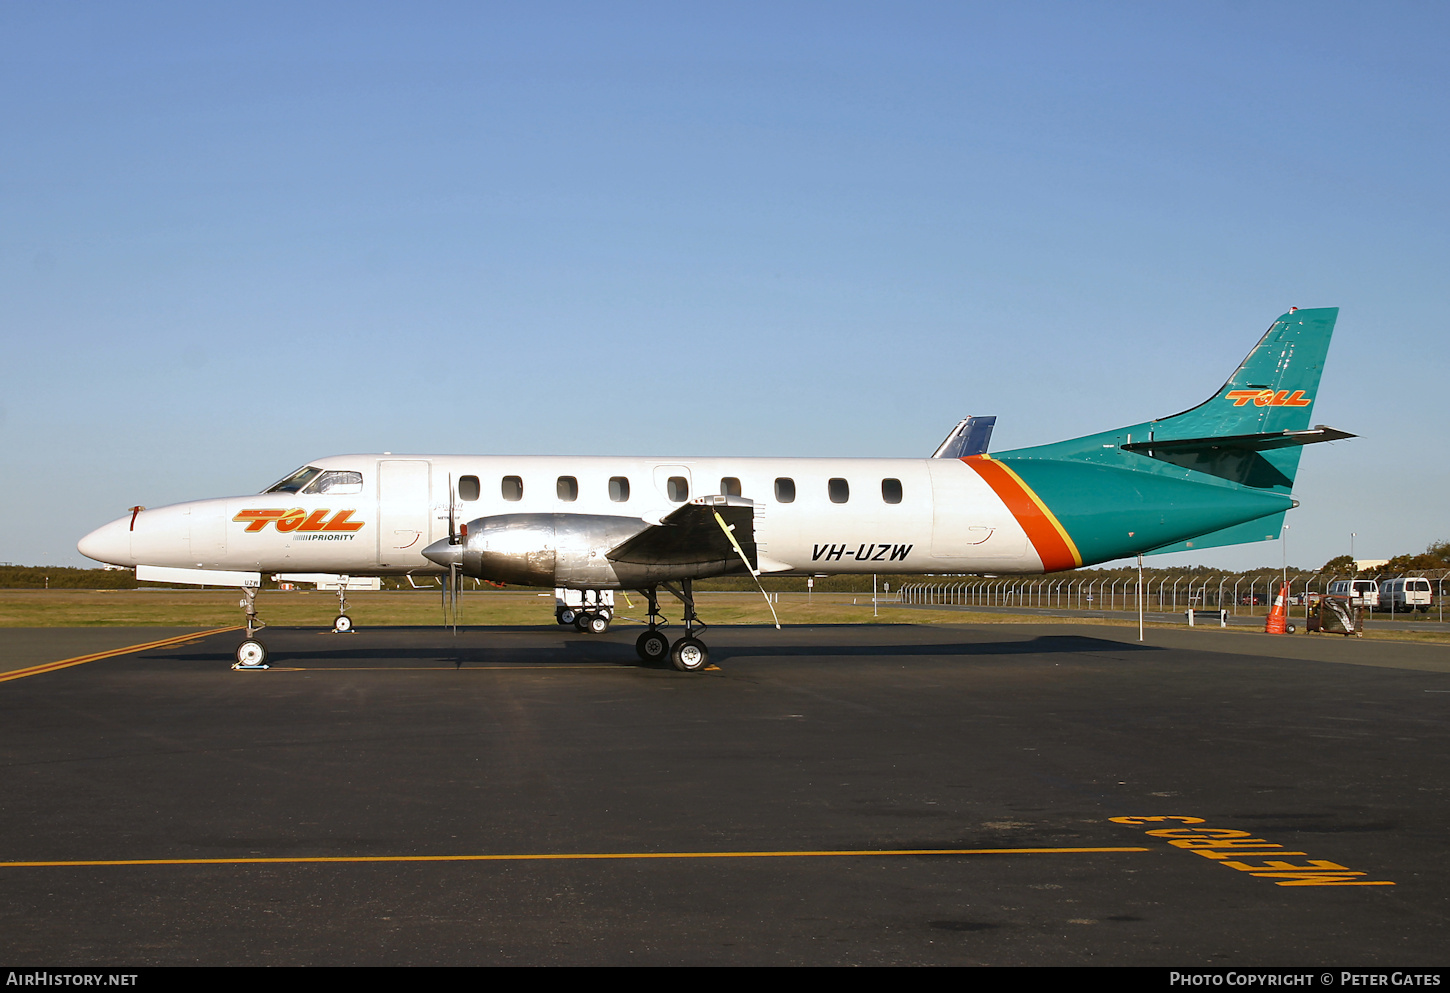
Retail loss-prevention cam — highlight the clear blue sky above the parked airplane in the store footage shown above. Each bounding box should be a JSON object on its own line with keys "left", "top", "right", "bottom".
{"left": 0, "top": 3, "right": 1450, "bottom": 567}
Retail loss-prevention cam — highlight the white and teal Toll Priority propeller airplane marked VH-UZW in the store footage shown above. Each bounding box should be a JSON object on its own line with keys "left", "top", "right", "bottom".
{"left": 78, "top": 307, "right": 1353, "bottom": 671}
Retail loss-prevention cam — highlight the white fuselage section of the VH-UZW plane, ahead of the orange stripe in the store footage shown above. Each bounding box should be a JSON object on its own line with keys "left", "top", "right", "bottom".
{"left": 80, "top": 454, "right": 1043, "bottom": 585}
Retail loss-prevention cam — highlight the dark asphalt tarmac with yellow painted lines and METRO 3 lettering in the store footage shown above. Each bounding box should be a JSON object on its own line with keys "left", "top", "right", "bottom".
{"left": 0, "top": 623, "right": 1450, "bottom": 967}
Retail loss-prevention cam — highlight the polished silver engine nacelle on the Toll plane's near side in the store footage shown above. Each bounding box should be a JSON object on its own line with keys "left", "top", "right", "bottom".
{"left": 463, "top": 513, "right": 650, "bottom": 589}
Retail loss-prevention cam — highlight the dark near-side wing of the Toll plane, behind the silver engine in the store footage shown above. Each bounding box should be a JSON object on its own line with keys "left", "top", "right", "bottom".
{"left": 606, "top": 496, "right": 758, "bottom": 571}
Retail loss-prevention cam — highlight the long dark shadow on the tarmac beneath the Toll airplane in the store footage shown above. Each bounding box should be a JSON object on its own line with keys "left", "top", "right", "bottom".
{"left": 152, "top": 626, "right": 1166, "bottom": 670}
